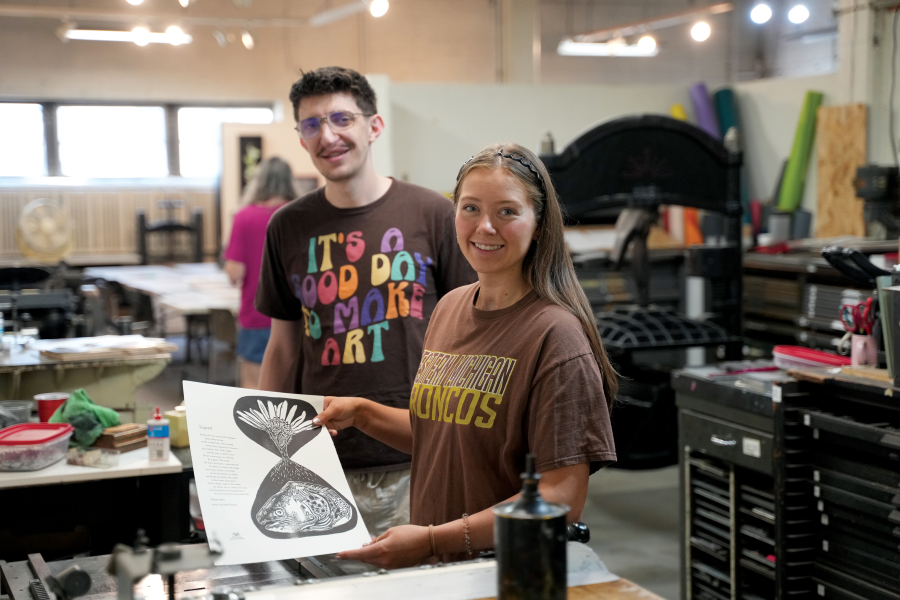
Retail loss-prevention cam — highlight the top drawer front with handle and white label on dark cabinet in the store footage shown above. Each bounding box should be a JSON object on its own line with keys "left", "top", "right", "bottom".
{"left": 678, "top": 409, "right": 773, "bottom": 475}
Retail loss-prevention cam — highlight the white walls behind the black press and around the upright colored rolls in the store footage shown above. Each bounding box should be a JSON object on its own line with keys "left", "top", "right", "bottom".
{"left": 391, "top": 75, "right": 837, "bottom": 218}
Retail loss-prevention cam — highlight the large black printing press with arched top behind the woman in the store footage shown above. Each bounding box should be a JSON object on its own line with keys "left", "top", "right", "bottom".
{"left": 541, "top": 115, "right": 743, "bottom": 469}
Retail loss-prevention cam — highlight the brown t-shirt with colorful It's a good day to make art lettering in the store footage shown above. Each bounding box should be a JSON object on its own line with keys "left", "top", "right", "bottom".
{"left": 256, "top": 181, "right": 476, "bottom": 472}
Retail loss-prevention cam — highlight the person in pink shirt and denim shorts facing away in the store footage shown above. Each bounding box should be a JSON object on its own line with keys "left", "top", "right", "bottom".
{"left": 225, "top": 157, "right": 299, "bottom": 389}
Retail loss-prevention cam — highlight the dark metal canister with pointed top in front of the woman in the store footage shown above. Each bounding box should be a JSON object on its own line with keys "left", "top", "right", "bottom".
{"left": 494, "top": 454, "right": 569, "bottom": 600}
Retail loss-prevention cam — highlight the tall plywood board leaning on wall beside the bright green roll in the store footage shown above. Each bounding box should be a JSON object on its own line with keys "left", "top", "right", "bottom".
{"left": 816, "top": 104, "right": 866, "bottom": 238}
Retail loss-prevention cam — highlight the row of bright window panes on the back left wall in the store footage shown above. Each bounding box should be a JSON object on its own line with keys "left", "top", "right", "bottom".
{"left": 0, "top": 101, "right": 275, "bottom": 179}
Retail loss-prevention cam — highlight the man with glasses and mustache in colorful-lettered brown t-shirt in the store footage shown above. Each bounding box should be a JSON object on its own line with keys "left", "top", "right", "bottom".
{"left": 256, "top": 67, "right": 476, "bottom": 535}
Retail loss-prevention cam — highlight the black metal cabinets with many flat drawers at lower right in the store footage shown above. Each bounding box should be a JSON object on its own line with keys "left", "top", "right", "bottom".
{"left": 673, "top": 367, "right": 900, "bottom": 600}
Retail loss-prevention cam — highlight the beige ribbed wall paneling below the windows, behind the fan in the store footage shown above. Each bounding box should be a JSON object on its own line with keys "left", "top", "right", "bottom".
{"left": 0, "top": 187, "right": 217, "bottom": 265}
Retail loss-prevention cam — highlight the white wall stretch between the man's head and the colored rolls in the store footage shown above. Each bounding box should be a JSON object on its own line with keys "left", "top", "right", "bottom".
{"left": 391, "top": 83, "right": 690, "bottom": 192}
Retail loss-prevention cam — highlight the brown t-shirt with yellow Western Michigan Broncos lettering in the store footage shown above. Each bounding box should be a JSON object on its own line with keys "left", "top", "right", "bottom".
{"left": 409, "top": 284, "right": 616, "bottom": 548}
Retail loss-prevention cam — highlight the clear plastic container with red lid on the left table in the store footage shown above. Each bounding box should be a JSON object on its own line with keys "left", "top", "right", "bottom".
{"left": 0, "top": 423, "right": 75, "bottom": 471}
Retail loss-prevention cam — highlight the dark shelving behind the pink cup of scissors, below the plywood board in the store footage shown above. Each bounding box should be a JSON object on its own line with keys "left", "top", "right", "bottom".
{"left": 743, "top": 252, "right": 874, "bottom": 352}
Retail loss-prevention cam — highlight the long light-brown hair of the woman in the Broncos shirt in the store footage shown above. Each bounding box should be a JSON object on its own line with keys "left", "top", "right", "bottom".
{"left": 453, "top": 144, "right": 619, "bottom": 409}
